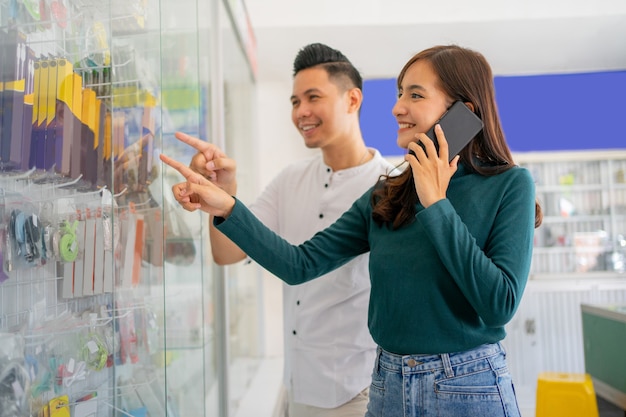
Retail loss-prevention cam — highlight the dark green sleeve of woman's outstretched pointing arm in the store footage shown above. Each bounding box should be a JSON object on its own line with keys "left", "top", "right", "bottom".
{"left": 213, "top": 193, "right": 369, "bottom": 285}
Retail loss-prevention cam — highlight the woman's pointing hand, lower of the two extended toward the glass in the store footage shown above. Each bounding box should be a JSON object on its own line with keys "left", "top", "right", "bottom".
{"left": 159, "top": 154, "right": 235, "bottom": 218}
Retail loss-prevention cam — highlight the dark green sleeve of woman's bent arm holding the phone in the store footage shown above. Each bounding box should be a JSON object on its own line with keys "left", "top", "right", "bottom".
{"left": 418, "top": 169, "right": 535, "bottom": 327}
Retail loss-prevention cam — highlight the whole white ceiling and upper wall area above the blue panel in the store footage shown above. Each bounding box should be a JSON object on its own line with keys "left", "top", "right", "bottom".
{"left": 247, "top": 0, "right": 626, "bottom": 81}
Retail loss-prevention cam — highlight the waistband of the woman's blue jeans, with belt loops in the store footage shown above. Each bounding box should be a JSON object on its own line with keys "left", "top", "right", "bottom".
{"left": 376, "top": 342, "right": 504, "bottom": 374}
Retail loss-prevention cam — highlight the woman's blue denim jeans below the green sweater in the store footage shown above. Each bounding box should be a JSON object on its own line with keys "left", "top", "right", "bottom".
{"left": 365, "top": 343, "right": 520, "bottom": 417}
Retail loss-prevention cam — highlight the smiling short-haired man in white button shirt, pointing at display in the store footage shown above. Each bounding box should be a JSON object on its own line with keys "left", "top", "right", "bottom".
{"left": 175, "top": 43, "right": 393, "bottom": 417}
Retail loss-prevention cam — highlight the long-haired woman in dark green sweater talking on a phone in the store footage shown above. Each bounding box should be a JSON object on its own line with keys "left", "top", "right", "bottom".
{"left": 162, "top": 46, "right": 541, "bottom": 417}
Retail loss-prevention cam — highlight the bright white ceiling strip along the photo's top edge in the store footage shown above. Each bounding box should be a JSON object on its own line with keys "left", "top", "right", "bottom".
{"left": 246, "top": 0, "right": 626, "bottom": 28}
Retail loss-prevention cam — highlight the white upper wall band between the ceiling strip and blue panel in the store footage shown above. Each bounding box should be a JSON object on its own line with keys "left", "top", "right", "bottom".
{"left": 252, "top": 14, "right": 626, "bottom": 81}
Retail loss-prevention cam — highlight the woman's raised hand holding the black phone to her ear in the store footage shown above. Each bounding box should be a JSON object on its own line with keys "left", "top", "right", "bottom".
{"left": 404, "top": 125, "right": 459, "bottom": 207}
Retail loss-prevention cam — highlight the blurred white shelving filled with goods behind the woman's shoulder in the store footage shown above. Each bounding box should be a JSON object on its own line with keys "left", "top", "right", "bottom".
{"left": 516, "top": 150, "right": 626, "bottom": 278}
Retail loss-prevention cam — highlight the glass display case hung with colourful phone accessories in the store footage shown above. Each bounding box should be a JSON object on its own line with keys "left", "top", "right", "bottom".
{"left": 0, "top": 0, "right": 258, "bottom": 417}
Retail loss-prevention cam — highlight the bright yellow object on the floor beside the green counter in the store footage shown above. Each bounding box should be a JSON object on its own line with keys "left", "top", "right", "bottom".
{"left": 535, "top": 372, "right": 598, "bottom": 417}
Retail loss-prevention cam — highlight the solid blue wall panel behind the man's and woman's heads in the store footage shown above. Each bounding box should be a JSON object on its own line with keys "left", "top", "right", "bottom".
{"left": 361, "top": 71, "right": 626, "bottom": 156}
